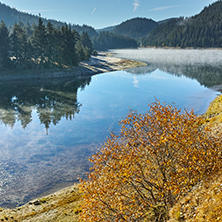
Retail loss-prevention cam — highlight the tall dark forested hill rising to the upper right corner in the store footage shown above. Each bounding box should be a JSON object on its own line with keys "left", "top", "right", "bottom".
{"left": 143, "top": 0, "right": 222, "bottom": 47}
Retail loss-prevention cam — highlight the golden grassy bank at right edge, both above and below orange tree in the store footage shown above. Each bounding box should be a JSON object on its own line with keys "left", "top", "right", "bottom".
{"left": 169, "top": 95, "right": 222, "bottom": 222}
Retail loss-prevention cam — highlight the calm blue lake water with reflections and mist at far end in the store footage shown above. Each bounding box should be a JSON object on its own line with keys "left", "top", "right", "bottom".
{"left": 0, "top": 50, "right": 222, "bottom": 207}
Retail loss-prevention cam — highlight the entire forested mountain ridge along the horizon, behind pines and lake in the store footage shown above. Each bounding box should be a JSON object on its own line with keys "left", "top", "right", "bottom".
{"left": 0, "top": 0, "right": 222, "bottom": 50}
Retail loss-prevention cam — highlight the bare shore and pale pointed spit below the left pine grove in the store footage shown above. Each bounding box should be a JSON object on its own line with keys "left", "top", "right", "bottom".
{"left": 0, "top": 52, "right": 147, "bottom": 83}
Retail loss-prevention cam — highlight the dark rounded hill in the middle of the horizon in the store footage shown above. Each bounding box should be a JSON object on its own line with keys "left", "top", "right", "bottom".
{"left": 112, "top": 18, "right": 158, "bottom": 39}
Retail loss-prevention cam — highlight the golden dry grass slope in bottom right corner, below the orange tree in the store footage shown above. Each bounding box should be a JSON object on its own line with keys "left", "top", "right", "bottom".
{"left": 170, "top": 172, "right": 222, "bottom": 222}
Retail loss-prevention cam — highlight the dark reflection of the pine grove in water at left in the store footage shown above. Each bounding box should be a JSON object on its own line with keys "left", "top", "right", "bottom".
{"left": 0, "top": 77, "right": 91, "bottom": 132}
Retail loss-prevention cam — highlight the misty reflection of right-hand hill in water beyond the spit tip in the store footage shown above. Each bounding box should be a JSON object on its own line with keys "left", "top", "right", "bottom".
{"left": 127, "top": 63, "right": 222, "bottom": 91}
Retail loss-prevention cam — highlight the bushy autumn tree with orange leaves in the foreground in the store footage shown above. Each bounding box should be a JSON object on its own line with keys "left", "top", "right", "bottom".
{"left": 80, "top": 101, "right": 222, "bottom": 221}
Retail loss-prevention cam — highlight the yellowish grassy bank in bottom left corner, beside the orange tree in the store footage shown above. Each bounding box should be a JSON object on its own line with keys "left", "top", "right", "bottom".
{"left": 0, "top": 186, "right": 81, "bottom": 222}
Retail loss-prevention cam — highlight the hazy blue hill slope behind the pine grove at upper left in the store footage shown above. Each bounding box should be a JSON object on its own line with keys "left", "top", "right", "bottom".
{"left": 0, "top": 3, "right": 98, "bottom": 37}
